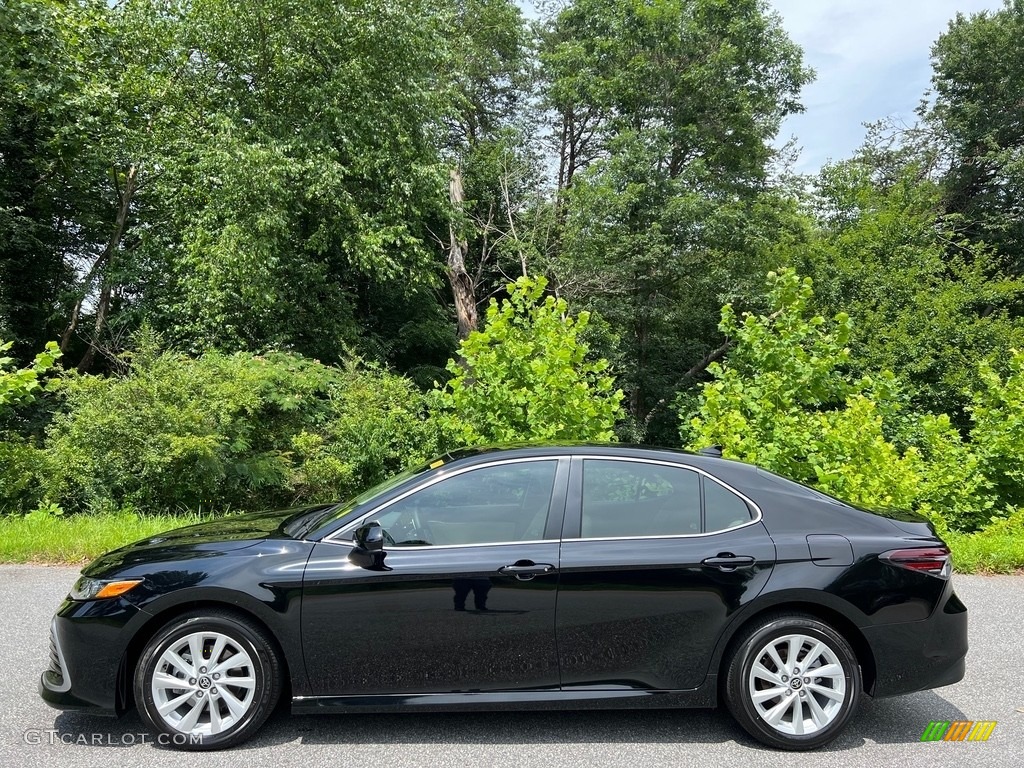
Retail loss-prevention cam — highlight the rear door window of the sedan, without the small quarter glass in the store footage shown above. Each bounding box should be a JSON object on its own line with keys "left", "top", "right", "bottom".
{"left": 581, "top": 459, "right": 700, "bottom": 539}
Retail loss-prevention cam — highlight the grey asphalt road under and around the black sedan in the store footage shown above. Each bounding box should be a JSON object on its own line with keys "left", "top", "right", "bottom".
{"left": 0, "top": 565, "right": 1024, "bottom": 768}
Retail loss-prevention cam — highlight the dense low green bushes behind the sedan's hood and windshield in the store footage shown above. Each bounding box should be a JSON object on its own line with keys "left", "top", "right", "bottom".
{"left": 46, "top": 349, "right": 435, "bottom": 512}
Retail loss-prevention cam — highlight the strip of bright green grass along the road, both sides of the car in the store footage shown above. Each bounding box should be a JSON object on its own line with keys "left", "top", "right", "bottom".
{"left": 0, "top": 511, "right": 1024, "bottom": 573}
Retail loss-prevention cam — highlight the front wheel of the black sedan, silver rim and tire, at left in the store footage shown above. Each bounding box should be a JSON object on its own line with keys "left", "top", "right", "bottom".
{"left": 135, "top": 609, "right": 282, "bottom": 751}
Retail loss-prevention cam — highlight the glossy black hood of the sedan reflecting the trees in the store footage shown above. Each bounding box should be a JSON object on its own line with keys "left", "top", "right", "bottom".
{"left": 82, "top": 507, "right": 317, "bottom": 577}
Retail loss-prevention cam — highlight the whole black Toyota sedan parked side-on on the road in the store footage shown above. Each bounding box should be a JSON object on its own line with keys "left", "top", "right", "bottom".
{"left": 40, "top": 445, "right": 967, "bottom": 750}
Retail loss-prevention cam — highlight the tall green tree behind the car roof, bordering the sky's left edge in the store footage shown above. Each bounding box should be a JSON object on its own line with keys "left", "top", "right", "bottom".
{"left": 541, "top": 0, "right": 810, "bottom": 441}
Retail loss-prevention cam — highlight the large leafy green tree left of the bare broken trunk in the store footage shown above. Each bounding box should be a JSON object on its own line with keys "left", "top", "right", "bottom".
{"left": 118, "top": 0, "right": 447, "bottom": 359}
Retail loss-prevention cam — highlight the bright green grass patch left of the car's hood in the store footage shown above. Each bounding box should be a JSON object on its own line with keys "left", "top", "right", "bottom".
{"left": 0, "top": 512, "right": 201, "bottom": 563}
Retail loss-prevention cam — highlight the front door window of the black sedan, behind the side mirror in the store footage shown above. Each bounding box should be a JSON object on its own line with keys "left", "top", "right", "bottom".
{"left": 356, "top": 460, "right": 558, "bottom": 547}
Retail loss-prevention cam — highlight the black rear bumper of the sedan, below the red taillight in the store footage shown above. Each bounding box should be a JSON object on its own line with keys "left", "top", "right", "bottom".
{"left": 863, "top": 587, "right": 968, "bottom": 697}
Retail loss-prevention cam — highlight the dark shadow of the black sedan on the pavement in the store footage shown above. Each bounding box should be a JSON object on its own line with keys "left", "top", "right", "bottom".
{"left": 46, "top": 691, "right": 967, "bottom": 752}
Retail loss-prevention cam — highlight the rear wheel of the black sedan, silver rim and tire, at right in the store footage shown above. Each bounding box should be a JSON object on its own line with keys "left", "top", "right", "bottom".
{"left": 725, "top": 613, "right": 863, "bottom": 750}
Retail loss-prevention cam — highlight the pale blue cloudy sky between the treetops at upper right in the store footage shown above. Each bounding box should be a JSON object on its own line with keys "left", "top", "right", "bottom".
{"left": 770, "top": 0, "right": 1002, "bottom": 173}
